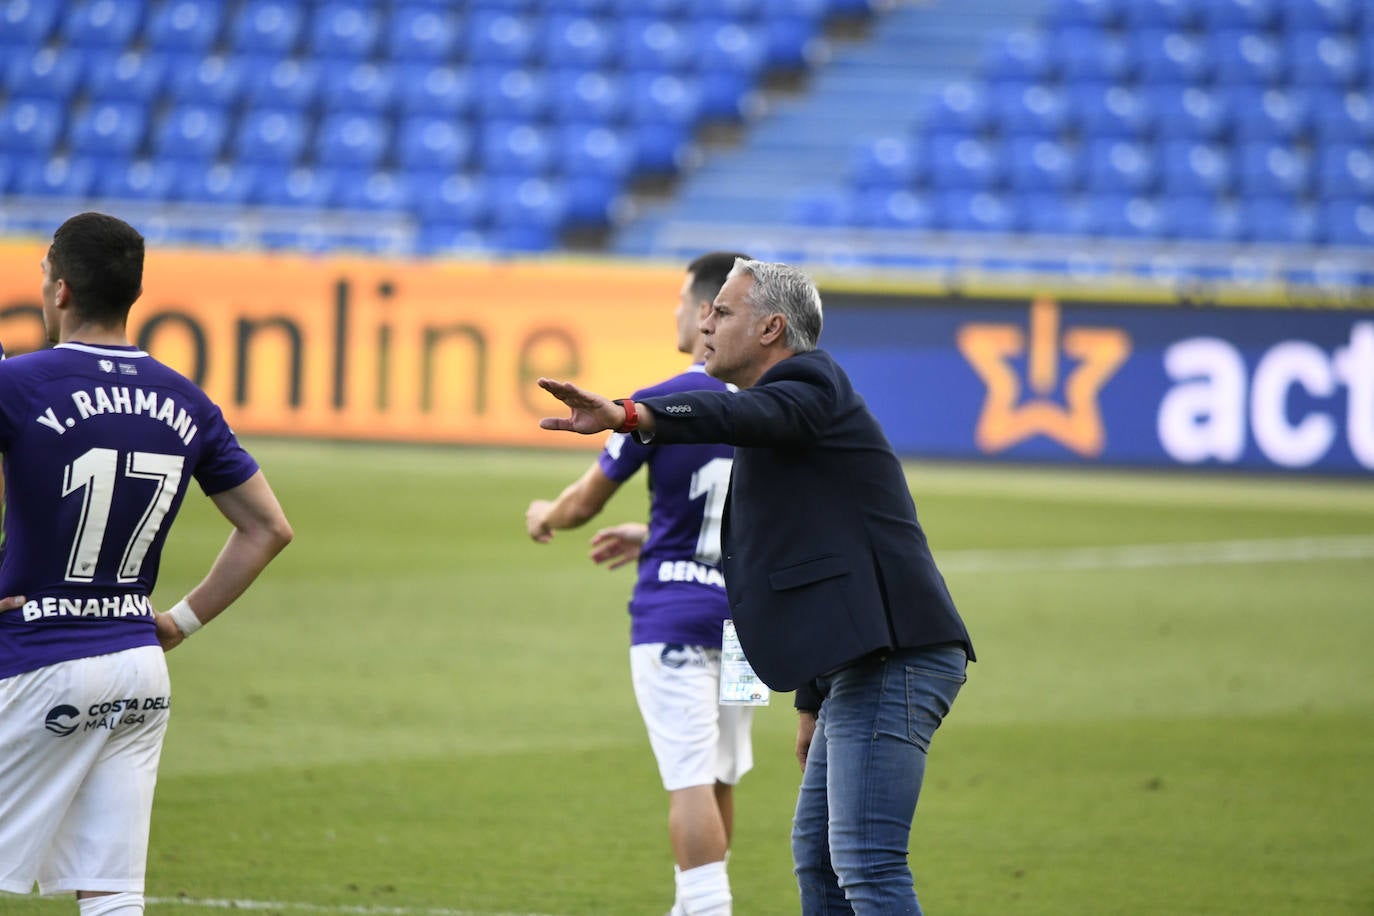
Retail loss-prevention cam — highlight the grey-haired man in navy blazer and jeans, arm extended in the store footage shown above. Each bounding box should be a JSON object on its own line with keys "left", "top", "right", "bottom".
{"left": 539, "top": 258, "right": 973, "bottom": 916}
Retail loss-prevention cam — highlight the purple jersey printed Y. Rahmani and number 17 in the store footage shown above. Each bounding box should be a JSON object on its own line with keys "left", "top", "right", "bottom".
{"left": 0, "top": 343, "right": 257, "bottom": 677}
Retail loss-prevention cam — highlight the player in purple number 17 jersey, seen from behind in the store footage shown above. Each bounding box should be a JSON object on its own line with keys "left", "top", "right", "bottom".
{"left": 0, "top": 213, "right": 291, "bottom": 916}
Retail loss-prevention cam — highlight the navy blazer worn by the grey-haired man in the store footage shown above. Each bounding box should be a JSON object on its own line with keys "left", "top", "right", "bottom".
{"left": 643, "top": 350, "right": 973, "bottom": 697}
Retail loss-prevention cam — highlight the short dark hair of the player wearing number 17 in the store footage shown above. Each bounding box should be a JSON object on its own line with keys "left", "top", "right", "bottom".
{"left": 48, "top": 213, "right": 143, "bottom": 324}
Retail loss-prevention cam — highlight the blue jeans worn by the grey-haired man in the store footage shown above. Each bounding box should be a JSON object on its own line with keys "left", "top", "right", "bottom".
{"left": 791, "top": 645, "right": 967, "bottom": 916}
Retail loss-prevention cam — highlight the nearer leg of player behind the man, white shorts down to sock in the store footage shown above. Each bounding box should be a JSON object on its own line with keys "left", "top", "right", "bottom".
{"left": 631, "top": 644, "right": 731, "bottom": 916}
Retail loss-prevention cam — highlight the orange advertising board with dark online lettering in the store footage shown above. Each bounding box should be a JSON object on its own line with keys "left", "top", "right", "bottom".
{"left": 0, "top": 244, "right": 684, "bottom": 448}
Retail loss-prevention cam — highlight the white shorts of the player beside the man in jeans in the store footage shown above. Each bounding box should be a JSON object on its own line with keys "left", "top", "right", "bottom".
{"left": 629, "top": 643, "right": 754, "bottom": 792}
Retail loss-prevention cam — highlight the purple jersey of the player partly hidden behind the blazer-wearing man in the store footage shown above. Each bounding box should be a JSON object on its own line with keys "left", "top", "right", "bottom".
{"left": 599, "top": 365, "right": 734, "bottom": 648}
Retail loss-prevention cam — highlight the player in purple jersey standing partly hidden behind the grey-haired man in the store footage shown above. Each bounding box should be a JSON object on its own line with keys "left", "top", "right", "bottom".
{"left": 525, "top": 251, "right": 753, "bottom": 916}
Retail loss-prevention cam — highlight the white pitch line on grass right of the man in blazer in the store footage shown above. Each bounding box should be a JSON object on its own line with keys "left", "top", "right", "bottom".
{"left": 936, "top": 534, "right": 1374, "bottom": 573}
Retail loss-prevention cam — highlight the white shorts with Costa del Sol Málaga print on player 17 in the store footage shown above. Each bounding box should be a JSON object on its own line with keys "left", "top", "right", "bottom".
{"left": 0, "top": 645, "right": 172, "bottom": 894}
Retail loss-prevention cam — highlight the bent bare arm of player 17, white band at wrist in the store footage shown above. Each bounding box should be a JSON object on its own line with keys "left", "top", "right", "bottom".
{"left": 155, "top": 471, "right": 294, "bottom": 651}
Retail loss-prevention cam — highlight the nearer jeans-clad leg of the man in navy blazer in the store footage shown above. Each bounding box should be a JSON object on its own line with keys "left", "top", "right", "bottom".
{"left": 822, "top": 648, "right": 966, "bottom": 916}
